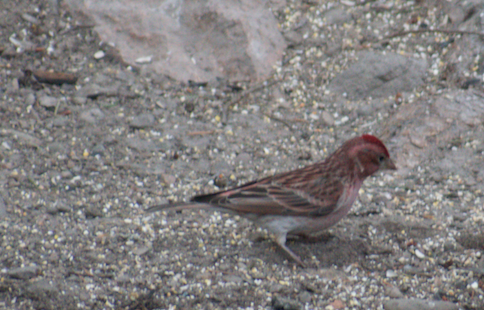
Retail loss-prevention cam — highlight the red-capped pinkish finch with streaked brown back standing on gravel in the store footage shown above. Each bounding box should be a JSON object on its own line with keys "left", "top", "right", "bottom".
{"left": 146, "top": 134, "right": 397, "bottom": 267}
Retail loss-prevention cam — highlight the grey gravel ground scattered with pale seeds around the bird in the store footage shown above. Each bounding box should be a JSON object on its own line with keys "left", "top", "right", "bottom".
{"left": 0, "top": 0, "right": 484, "bottom": 309}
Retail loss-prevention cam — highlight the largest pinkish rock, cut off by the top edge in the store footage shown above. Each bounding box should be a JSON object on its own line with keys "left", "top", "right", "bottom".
{"left": 63, "top": 0, "right": 286, "bottom": 82}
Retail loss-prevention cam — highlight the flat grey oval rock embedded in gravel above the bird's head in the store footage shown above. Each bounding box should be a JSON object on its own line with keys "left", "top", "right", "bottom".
{"left": 329, "top": 52, "right": 427, "bottom": 99}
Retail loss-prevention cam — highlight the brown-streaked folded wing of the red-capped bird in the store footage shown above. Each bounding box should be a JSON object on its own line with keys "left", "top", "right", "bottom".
{"left": 193, "top": 182, "right": 344, "bottom": 216}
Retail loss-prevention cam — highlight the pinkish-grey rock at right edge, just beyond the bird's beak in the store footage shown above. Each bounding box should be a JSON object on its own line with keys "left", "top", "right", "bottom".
{"left": 375, "top": 90, "right": 484, "bottom": 191}
